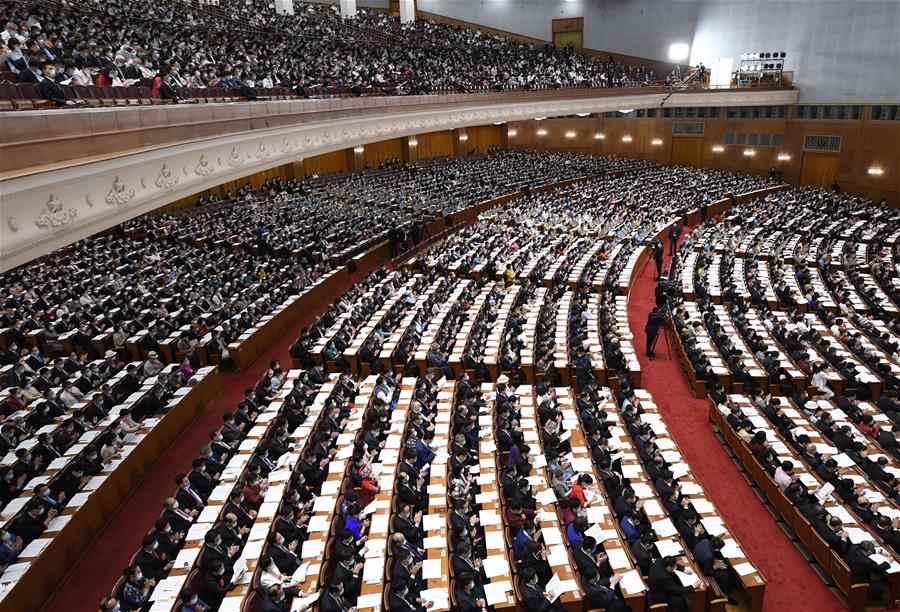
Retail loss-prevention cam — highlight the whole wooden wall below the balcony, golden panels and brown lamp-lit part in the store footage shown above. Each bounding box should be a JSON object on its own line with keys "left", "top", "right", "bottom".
{"left": 163, "top": 111, "right": 900, "bottom": 216}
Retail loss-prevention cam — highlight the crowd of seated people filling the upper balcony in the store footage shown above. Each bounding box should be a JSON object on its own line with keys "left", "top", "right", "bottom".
{"left": 0, "top": 0, "right": 655, "bottom": 99}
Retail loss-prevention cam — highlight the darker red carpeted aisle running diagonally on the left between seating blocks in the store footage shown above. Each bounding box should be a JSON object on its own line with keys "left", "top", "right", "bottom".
{"left": 44, "top": 275, "right": 362, "bottom": 612}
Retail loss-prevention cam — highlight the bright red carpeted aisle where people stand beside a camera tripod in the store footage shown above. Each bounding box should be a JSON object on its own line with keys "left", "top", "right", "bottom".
{"left": 628, "top": 233, "right": 846, "bottom": 612}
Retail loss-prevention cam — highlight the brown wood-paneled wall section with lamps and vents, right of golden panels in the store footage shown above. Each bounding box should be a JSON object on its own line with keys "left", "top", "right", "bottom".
{"left": 510, "top": 117, "right": 900, "bottom": 206}
